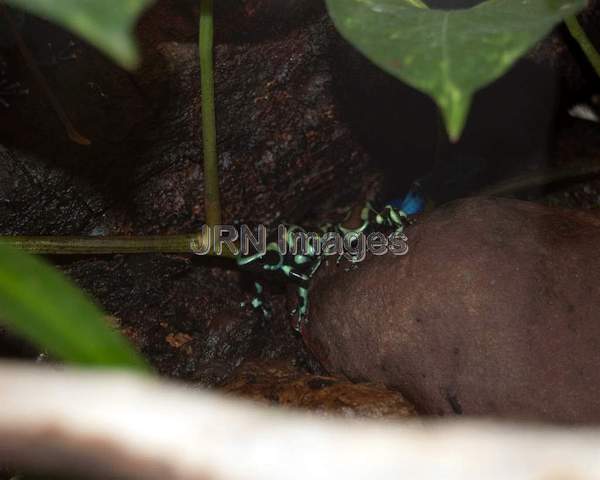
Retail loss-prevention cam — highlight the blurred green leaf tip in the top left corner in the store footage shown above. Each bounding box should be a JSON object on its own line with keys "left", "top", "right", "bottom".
{"left": 5, "top": 0, "right": 154, "bottom": 69}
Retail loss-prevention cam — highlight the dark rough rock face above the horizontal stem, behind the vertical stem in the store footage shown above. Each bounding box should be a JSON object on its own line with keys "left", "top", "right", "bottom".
{"left": 0, "top": 0, "right": 376, "bottom": 235}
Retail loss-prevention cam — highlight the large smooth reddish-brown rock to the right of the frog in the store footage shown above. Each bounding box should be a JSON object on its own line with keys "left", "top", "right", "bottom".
{"left": 304, "top": 198, "right": 600, "bottom": 422}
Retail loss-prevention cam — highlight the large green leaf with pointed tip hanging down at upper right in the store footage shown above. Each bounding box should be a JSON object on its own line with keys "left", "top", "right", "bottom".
{"left": 327, "top": 0, "right": 586, "bottom": 140}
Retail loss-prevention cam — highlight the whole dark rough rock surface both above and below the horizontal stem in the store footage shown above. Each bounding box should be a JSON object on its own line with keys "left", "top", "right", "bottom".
{"left": 0, "top": 0, "right": 369, "bottom": 383}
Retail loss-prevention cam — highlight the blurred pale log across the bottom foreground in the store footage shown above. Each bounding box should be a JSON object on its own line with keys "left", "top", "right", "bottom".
{"left": 0, "top": 363, "right": 600, "bottom": 480}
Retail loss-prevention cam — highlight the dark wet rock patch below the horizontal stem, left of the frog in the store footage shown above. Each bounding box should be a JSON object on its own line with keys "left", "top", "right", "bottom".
{"left": 62, "top": 255, "right": 314, "bottom": 386}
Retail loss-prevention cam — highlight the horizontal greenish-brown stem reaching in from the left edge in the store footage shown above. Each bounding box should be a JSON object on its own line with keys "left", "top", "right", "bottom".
{"left": 0, "top": 235, "right": 234, "bottom": 258}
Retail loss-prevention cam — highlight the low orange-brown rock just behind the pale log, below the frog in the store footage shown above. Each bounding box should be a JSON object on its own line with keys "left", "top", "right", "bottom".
{"left": 222, "top": 362, "right": 416, "bottom": 418}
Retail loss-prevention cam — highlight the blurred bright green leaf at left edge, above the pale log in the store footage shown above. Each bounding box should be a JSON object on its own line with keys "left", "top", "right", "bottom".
{"left": 0, "top": 243, "right": 147, "bottom": 370}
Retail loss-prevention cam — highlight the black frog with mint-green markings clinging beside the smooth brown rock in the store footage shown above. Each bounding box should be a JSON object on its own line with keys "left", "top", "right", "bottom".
{"left": 237, "top": 202, "right": 409, "bottom": 332}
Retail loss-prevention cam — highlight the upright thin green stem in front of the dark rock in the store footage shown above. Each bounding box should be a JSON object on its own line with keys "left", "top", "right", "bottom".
{"left": 199, "top": 0, "right": 221, "bottom": 231}
